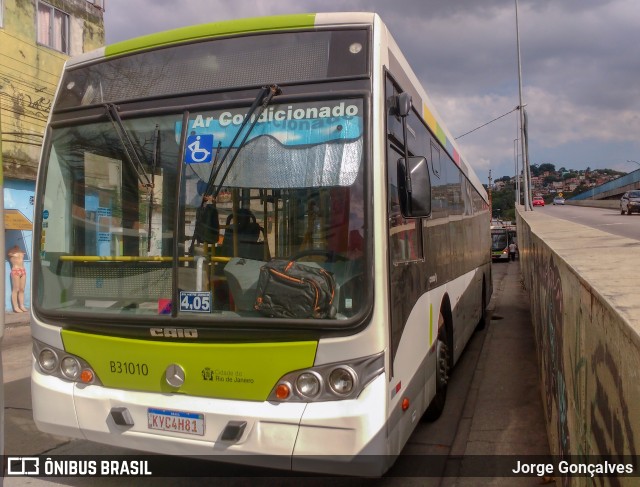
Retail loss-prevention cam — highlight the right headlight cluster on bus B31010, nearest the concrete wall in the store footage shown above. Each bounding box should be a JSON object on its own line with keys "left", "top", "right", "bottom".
{"left": 267, "top": 352, "right": 384, "bottom": 402}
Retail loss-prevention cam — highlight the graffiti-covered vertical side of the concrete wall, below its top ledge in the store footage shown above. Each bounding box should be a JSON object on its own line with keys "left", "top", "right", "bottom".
{"left": 523, "top": 224, "right": 640, "bottom": 486}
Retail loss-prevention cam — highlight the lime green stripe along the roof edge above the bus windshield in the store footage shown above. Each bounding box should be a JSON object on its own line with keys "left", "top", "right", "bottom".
{"left": 105, "top": 14, "right": 316, "bottom": 57}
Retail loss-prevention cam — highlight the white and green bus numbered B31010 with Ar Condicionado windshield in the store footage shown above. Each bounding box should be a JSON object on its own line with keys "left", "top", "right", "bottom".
{"left": 32, "top": 13, "right": 492, "bottom": 474}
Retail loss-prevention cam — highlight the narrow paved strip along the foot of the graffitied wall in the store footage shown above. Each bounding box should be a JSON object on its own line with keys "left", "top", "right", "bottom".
{"left": 441, "top": 261, "right": 550, "bottom": 487}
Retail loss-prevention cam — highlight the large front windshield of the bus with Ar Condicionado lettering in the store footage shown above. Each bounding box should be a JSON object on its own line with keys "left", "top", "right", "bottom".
{"left": 40, "top": 99, "right": 367, "bottom": 322}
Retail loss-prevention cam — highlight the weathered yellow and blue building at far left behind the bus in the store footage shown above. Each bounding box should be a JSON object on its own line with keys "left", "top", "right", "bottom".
{"left": 0, "top": 0, "right": 105, "bottom": 310}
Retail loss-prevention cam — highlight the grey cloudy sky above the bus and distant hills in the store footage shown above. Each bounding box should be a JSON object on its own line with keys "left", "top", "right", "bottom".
{"left": 104, "top": 0, "right": 640, "bottom": 182}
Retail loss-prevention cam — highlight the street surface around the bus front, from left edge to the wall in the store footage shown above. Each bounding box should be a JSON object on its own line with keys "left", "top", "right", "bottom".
{"left": 3, "top": 263, "right": 549, "bottom": 487}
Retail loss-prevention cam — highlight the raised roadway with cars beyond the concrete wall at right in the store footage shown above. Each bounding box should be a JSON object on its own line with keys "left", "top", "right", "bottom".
{"left": 533, "top": 205, "right": 640, "bottom": 240}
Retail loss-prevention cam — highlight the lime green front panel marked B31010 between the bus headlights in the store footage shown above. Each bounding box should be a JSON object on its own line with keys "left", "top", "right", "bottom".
{"left": 62, "top": 330, "right": 317, "bottom": 401}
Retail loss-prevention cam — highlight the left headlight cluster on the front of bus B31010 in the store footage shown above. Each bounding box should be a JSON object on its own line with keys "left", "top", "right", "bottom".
{"left": 33, "top": 338, "right": 102, "bottom": 385}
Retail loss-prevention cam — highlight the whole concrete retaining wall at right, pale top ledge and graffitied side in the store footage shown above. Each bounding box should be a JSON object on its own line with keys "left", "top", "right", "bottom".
{"left": 516, "top": 207, "right": 640, "bottom": 485}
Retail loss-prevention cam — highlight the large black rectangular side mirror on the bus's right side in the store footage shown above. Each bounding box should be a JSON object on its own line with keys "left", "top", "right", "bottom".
{"left": 398, "top": 157, "right": 431, "bottom": 218}
